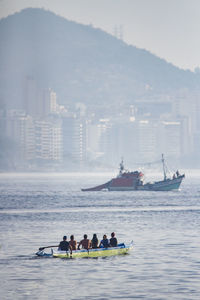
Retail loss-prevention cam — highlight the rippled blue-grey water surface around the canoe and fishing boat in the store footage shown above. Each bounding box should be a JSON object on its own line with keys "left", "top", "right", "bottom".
{"left": 0, "top": 174, "right": 200, "bottom": 300}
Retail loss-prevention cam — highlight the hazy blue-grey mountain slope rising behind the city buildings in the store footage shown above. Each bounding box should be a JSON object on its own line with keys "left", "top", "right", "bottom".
{"left": 0, "top": 8, "right": 200, "bottom": 107}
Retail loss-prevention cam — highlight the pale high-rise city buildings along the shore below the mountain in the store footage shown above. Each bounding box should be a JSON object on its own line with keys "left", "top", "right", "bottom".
{"left": 0, "top": 77, "right": 197, "bottom": 171}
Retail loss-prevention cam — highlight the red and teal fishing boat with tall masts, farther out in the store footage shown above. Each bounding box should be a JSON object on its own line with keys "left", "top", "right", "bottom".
{"left": 82, "top": 154, "right": 185, "bottom": 192}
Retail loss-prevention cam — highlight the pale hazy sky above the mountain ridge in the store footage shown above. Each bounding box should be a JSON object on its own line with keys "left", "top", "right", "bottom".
{"left": 0, "top": 0, "right": 200, "bottom": 70}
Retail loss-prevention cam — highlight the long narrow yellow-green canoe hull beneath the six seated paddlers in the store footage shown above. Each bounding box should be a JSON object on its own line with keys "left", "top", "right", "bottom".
{"left": 36, "top": 241, "right": 133, "bottom": 258}
